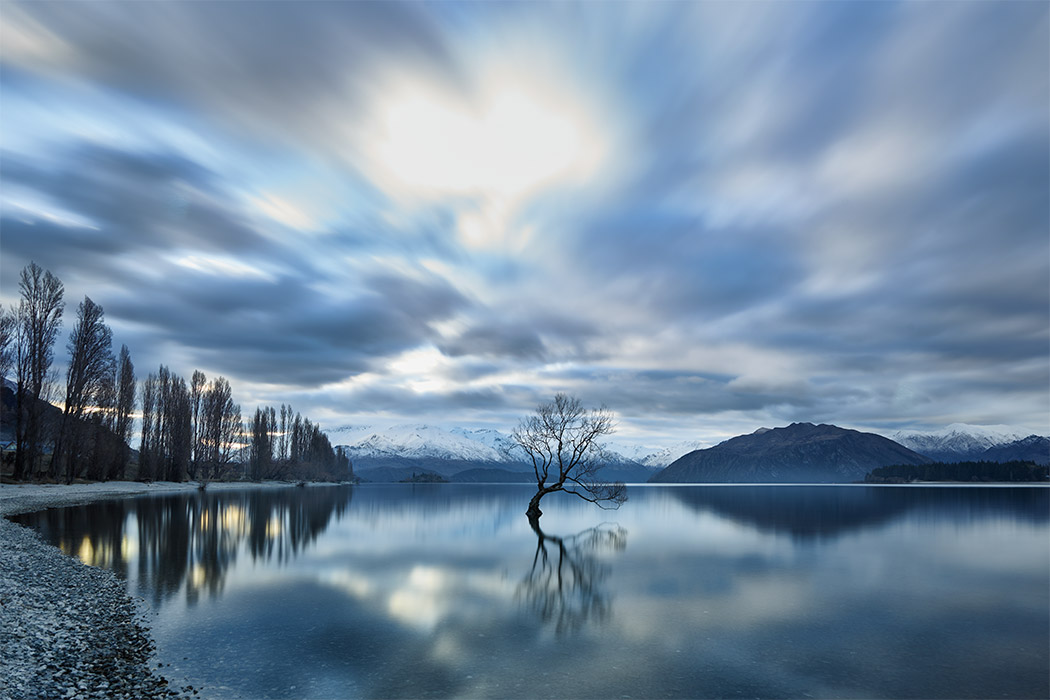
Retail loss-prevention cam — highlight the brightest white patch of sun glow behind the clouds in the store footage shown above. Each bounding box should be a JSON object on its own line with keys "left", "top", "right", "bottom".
{"left": 373, "top": 70, "right": 605, "bottom": 216}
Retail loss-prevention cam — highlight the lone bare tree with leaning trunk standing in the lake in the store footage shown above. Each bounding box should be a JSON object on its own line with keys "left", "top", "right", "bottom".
{"left": 512, "top": 394, "right": 627, "bottom": 523}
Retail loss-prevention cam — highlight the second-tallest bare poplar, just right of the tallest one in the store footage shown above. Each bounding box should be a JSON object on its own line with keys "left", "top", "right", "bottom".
{"left": 51, "top": 297, "right": 113, "bottom": 483}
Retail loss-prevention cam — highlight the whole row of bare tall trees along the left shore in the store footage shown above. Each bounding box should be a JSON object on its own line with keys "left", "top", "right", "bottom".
{"left": 0, "top": 262, "right": 353, "bottom": 483}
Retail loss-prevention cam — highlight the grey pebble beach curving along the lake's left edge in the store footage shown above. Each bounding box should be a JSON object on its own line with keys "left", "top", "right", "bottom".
{"left": 0, "top": 482, "right": 323, "bottom": 700}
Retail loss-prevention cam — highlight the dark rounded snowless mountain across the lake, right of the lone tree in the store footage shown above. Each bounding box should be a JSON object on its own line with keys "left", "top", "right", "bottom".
{"left": 650, "top": 423, "right": 930, "bottom": 484}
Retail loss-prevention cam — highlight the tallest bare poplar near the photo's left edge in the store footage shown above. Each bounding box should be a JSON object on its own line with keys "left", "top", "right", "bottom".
{"left": 14, "top": 262, "right": 65, "bottom": 480}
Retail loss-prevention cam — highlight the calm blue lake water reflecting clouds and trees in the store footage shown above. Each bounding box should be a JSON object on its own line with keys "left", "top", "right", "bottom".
{"left": 10, "top": 485, "right": 1050, "bottom": 698}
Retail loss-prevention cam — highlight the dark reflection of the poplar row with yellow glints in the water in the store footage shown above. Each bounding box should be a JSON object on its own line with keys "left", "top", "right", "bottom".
{"left": 12, "top": 486, "right": 353, "bottom": 607}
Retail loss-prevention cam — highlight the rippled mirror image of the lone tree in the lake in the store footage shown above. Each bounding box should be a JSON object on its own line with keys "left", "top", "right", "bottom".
{"left": 516, "top": 518, "right": 627, "bottom": 635}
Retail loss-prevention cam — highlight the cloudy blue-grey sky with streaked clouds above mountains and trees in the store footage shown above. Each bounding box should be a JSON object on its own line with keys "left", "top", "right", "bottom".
{"left": 0, "top": 1, "right": 1050, "bottom": 446}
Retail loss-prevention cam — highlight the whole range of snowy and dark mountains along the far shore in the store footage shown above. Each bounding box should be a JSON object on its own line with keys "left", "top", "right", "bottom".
{"left": 329, "top": 423, "right": 1050, "bottom": 483}
